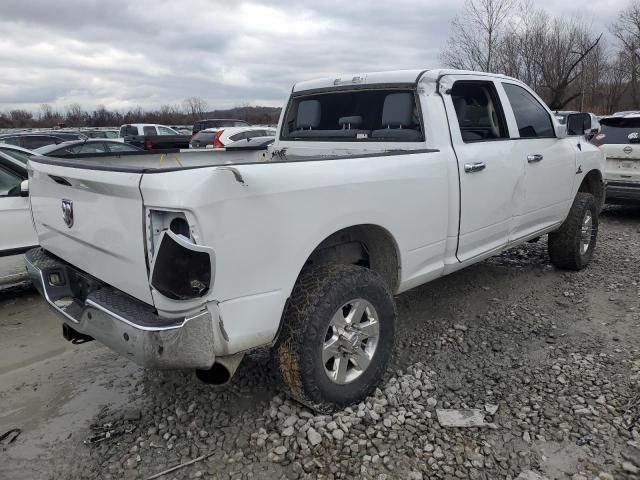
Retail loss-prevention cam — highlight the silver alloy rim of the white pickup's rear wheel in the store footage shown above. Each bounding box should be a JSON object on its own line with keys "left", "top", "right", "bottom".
{"left": 322, "top": 298, "right": 380, "bottom": 385}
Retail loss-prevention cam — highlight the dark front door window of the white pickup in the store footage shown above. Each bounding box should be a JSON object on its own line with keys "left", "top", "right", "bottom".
{"left": 502, "top": 83, "right": 556, "bottom": 138}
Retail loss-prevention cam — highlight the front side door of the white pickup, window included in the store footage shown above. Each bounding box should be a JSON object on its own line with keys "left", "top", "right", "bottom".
{"left": 501, "top": 81, "right": 580, "bottom": 241}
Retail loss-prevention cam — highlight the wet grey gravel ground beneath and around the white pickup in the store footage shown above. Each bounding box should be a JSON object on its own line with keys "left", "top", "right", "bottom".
{"left": 0, "top": 207, "right": 640, "bottom": 480}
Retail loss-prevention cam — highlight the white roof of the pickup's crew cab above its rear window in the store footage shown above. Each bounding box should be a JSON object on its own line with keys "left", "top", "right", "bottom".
{"left": 292, "top": 68, "right": 518, "bottom": 92}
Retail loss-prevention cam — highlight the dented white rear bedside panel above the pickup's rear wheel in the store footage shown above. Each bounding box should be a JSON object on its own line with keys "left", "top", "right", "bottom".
{"left": 141, "top": 152, "right": 448, "bottom": 354}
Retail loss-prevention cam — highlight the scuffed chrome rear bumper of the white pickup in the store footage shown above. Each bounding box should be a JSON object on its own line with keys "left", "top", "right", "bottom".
{"left": 25, "top": 248, "right": 215, "bottom": 369}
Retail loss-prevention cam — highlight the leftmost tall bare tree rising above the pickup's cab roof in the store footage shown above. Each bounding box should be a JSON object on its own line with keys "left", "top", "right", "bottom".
{"left": 441, "top": 0, "right": 517, "bottom": 72}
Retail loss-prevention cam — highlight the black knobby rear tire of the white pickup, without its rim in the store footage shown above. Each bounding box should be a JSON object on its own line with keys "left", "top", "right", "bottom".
{"left": 274, "top": 265, "right": 397, "bottom": 413}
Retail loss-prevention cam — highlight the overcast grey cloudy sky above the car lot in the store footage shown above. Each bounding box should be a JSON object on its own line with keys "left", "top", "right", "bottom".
{"left": 0, "top": 0, "right": 627, "bottom": 111}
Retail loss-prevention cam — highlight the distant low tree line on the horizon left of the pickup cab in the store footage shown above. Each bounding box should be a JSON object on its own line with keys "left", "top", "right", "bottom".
{"left": 0, "top": 97, "right": 280, "bottom": 128}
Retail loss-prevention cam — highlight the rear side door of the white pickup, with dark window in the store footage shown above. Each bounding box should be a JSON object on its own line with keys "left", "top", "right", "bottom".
{"left": 439, "top": 75, "right": 524, "bottom": 262}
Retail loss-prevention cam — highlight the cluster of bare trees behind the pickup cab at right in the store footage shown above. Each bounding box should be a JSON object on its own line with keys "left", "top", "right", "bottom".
{"left": 441, "top": 0, "right": 640, "bottom": 114}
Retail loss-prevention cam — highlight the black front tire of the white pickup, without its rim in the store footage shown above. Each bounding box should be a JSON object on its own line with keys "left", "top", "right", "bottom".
{"left": 548, "top": 192, "right": 598, "bottom": 270}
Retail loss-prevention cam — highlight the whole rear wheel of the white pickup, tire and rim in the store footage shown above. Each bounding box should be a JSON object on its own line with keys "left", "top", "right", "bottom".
{"left": 274, "top": 265, "right": 396, "bottom": 412}
